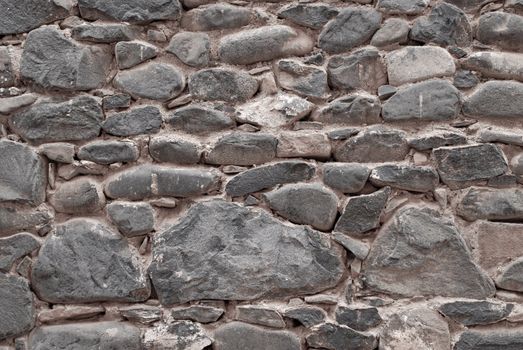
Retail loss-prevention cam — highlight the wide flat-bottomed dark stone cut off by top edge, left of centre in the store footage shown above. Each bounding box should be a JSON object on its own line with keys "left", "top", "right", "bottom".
{"left": 78, "top": 0, "right": 182, "bottom": 23}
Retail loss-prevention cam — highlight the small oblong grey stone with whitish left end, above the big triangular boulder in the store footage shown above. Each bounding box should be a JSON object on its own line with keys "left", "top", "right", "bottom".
{"left": 369, "top": 164, "right": 439, "bottom": 192}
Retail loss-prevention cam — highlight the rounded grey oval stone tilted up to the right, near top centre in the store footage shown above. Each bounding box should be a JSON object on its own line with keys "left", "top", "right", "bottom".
{"left": 318, "top": 7, "right": 382, "bottom": 53}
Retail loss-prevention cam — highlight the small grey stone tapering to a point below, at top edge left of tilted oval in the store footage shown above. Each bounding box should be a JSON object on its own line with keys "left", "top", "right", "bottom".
{"left": 278, "top": 3, "right": 339, "bottom": 29}
